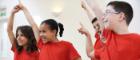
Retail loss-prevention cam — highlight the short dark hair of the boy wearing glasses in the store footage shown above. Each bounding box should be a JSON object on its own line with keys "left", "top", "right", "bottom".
{"left": 107, "top": 1, "right": 133, "bottom": 25}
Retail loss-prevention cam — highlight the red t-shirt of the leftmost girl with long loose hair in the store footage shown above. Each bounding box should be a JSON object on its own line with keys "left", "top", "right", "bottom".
{"left": 12, "top": 46, "right": 39, "bottom": 60}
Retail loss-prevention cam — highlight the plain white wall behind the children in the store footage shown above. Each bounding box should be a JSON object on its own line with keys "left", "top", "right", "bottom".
{"left": 0, "top": 0, "right": 140, "bottom": 60}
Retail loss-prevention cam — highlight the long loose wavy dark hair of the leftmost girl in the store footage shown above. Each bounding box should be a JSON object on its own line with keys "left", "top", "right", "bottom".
{"left": 16, "top": 25, "right": 38, "bottom": 53}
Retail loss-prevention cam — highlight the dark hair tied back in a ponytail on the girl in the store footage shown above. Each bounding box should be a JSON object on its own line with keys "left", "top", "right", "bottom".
{"left": 41, "top": 19, "right": 64, "bottom": 37}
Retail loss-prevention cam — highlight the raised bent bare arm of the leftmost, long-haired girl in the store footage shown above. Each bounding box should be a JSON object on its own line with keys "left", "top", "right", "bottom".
{"left": 7, "top": 6, "right": 20, "bottom": 44}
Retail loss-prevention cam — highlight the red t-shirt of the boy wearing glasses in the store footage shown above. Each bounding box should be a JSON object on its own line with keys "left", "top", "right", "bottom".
{"left": 94, "top": 30, "right": 140, "bottom": 60}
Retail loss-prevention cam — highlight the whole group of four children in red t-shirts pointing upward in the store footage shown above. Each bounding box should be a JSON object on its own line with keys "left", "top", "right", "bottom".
{"left": 7, "top": 1, "right": 140, "bottom": 60}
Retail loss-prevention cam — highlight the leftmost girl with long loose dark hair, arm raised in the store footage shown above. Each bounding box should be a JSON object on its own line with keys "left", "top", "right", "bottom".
{"left": 7, "top": 5, "right": 39, "bottom": 60}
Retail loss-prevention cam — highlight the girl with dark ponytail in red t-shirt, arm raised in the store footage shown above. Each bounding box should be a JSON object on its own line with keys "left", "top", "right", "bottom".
{"left": 17, "top": 1, "right": 81, "bottom": 60}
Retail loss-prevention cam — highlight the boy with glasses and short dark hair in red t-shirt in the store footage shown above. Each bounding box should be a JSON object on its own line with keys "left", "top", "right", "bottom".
{"left": 79, "top": 1, "right": 140, "bottom": 60}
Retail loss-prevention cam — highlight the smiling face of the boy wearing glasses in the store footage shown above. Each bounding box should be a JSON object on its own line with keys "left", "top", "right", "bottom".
{"left": 103, "top": 5, "right": 121, "bottom": 30}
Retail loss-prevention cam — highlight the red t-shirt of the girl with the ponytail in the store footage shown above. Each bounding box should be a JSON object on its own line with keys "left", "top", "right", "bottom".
{"left": 38, "top": 39, "right": 80, "bottom": 60}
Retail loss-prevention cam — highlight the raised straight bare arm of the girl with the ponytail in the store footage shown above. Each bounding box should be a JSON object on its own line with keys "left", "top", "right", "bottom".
{"left": 19, "top": 2, "right": 39, "bottom": 42}
